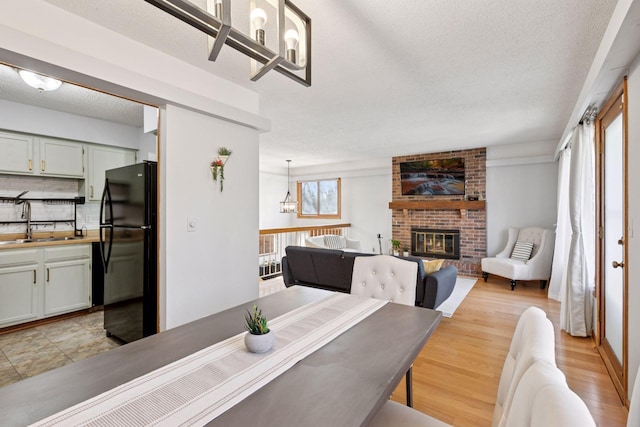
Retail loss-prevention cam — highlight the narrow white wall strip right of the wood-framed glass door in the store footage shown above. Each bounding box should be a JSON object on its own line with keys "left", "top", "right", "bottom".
{"left": 625, "top": 51, "right": 640, "bottom": 404}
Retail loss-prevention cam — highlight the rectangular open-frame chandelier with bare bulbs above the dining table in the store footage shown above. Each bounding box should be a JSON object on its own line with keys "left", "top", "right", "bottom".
{"left": 145, "top": 0, "right": 311, "bottom": 87}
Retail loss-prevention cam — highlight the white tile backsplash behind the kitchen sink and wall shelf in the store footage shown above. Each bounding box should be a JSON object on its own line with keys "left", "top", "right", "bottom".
{"left": 0, "top": 174, "right": 100, "bottom": 234}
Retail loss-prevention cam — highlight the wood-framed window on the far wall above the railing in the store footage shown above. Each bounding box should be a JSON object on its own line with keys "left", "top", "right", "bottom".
{"left": 297, "top": 178, "right": 340, "bottom": 218}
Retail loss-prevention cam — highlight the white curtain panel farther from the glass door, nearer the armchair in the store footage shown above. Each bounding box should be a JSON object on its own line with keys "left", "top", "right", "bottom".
{"left": 547, "top": 146, "right": 571, "bottom": 302}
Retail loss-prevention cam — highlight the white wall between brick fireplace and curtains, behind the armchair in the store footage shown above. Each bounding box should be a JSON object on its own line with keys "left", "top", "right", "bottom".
{"left": 486, "top": 141, "right": 558, "bottom": 256}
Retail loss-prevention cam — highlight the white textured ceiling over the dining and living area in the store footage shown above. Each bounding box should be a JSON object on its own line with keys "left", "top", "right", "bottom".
{"left": 8, "top": 0, "right": 616, "bottom": 170}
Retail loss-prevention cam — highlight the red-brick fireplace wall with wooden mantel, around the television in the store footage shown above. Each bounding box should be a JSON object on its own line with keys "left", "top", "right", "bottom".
{"left": 389, "top": 148, "right": 487, "bottom": 277}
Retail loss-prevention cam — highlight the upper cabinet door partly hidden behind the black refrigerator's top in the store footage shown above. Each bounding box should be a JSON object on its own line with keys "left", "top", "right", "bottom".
{"left": 86, "top": 146, "right": 136, "bottom": 200}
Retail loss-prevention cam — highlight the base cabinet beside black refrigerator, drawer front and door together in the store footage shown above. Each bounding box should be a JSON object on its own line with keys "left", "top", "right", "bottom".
{"left": 44, "top": 245, "right": 91, "bottom": 317}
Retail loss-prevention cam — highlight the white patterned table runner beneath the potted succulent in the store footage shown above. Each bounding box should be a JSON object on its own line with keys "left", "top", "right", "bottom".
{"left": 33, "top": 293, "right": 386, "bottom": 427}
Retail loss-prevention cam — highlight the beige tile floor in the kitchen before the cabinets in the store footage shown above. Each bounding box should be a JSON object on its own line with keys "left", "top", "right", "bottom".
{"left": 0, "top": 311, "right": 119, "bottom": 387}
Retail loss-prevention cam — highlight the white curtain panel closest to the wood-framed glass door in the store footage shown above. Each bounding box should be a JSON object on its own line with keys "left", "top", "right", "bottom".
{"left": 560, "top": 124, "right": 595, "bottom": 337}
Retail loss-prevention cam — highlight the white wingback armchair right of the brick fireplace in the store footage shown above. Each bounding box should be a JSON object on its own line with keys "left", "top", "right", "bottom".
{"left": 481, "top": 227, "right": 555, "bottom": 290}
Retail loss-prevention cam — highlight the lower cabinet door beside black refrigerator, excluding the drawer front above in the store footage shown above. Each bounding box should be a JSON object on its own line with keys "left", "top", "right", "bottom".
{"left": 44, "top": 259, "right": 91, "bottom": 317}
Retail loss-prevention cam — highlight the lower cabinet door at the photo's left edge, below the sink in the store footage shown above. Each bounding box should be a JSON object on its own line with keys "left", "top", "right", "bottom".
{"left": 0, "top": 264, "right": 39, "bottom": 327}
